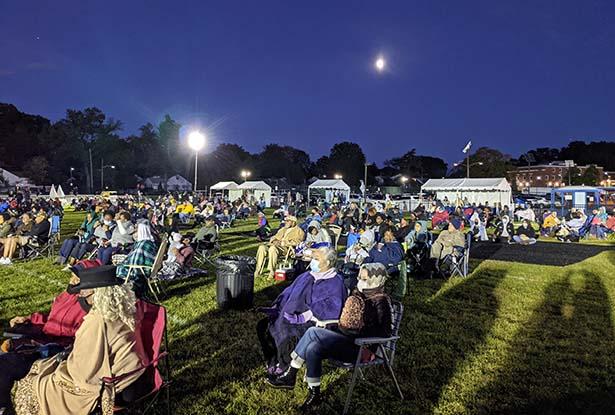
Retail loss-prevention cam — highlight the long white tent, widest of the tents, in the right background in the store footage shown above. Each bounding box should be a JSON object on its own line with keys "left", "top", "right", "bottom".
{"left": 421, "top": 178, "right": 512, "bottom": 206}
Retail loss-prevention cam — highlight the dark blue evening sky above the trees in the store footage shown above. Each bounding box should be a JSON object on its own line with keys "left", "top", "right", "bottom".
{"left": 0, "top": 0, "right": 615, "bottom": 163}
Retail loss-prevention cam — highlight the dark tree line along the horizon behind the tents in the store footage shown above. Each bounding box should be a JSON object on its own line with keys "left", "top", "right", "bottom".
{"left": 0, "top": 104, "right": 615, "bottom": 192}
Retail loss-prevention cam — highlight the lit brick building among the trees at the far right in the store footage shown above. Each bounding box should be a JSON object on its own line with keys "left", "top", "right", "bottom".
{"left": 508, "top": 160, "right": 615, "bottom": 194}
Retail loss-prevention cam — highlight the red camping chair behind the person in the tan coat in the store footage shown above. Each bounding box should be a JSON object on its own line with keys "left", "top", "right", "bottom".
{"left": 93, "top": 301, "right": 171, "bottom": 415}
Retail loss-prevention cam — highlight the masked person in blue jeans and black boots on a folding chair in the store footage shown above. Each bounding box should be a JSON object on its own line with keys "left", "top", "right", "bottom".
{"left": 267, "top": 264, "right": 392, "bottom": 412}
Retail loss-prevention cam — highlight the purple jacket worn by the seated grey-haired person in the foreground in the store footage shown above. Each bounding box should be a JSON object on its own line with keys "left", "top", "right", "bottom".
{"left": 269, "top": 272, "right": 347, "bottom": 347}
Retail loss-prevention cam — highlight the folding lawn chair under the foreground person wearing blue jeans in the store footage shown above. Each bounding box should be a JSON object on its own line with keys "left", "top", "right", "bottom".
{"left": 330, "top": 301, "right": 404, "bottom": 415}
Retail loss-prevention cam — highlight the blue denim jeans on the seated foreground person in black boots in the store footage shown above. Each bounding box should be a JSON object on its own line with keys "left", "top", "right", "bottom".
{"left": 291, "top": 327, "right": 359, "bottom": 384}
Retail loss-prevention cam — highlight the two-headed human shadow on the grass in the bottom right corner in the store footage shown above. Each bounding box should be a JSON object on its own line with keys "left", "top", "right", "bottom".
{"left": 466, "top": 271, "right": 615, "bottom": 415}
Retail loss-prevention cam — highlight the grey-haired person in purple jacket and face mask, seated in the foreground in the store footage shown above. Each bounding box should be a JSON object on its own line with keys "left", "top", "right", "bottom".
{"left": 256, "top": 248, "right": 347, "bottom": 375}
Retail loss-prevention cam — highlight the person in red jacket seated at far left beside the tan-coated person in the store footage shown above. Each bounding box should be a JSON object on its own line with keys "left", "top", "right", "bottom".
{"left": 0, "top": 267, "right": 90, "bottom": 414}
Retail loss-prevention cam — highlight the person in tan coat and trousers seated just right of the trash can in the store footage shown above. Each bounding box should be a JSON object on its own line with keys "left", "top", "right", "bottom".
{"left": 254, "top": 215, "right": 305, "bottom": 277}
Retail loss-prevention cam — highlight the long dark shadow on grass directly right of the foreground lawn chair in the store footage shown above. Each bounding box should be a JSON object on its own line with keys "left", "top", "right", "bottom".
{"left": 312, "top": 269, "right": 506, "bottom": 414}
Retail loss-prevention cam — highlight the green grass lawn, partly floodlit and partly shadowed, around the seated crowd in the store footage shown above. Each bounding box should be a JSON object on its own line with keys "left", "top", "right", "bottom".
{"left": 0, "top": 214, "right": 615, "bottom": 415}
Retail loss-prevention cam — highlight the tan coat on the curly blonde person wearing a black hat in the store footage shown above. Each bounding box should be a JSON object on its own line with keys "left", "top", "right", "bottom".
{"left": 15, "top": 313, "right": 145, "bottom": 415}
